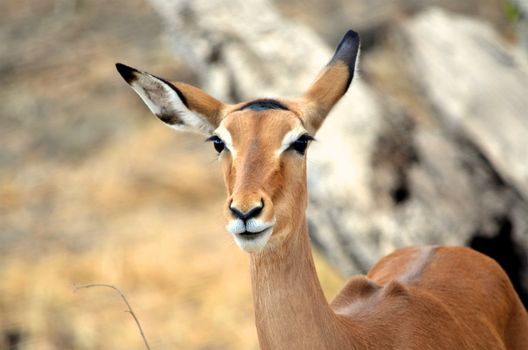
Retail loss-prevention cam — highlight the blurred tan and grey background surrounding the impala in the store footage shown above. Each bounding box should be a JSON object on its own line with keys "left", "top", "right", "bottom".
{"left": 0, "top": 0, "right": 528, "bottom": 349}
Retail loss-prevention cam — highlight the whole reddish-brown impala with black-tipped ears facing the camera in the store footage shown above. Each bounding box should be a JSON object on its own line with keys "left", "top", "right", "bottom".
{"left": 116, "top": 31, "right": 528, "bottom": 350}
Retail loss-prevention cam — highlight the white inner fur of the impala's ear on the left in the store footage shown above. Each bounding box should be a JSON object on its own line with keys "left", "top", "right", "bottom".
{"left": 130, "top": 73, "right": 214, "bottom": 134}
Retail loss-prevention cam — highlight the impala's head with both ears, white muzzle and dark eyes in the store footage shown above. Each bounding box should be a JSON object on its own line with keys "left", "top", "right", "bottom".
{"left": 116, "top": 31, "right": 359, "bottom": 251}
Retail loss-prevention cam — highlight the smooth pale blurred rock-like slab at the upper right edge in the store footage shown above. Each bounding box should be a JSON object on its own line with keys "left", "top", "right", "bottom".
{"left": 404, "top": 10, "right": 528, "bottom": 200}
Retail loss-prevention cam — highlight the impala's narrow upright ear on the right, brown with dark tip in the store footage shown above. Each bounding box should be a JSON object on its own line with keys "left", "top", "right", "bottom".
{"left": 298, "top": 30, "right": 360, "bottom": 133}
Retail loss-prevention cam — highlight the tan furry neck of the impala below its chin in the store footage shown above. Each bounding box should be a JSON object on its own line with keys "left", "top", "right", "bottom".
{"left": 251, "top": 218, "right": 352, "bottom": 349}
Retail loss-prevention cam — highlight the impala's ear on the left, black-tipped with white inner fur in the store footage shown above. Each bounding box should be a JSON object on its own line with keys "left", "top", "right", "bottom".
{"left": 116, "top": 63, "right": 225, "bottom": 134}
